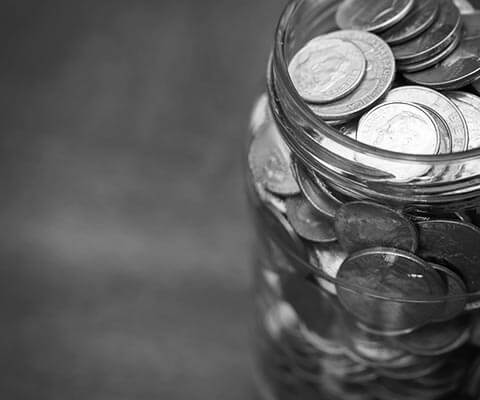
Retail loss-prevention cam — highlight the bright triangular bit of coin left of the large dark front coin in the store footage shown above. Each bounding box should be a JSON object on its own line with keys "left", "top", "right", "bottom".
{"left": 313, "top": 243, "right": 348, "bottom": 295}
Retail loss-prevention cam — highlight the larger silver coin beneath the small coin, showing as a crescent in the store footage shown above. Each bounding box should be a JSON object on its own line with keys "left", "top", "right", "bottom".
{"left": 310, "top": 31, "right": 395, "bottom": 120}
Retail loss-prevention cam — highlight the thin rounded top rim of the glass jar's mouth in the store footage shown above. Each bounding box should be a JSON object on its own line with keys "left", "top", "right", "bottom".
{"left": 270, "top": 0, "right": 480, "bottom": 166}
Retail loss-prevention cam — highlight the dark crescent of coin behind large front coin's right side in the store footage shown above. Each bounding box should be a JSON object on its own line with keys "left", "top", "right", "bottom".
{"left": 430, "top": 263, "right": 467, "bottom": 322}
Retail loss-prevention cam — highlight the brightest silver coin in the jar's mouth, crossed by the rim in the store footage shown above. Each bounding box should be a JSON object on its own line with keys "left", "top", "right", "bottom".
{"left": 356, "top": 102, "right": 440, "bottom": 180}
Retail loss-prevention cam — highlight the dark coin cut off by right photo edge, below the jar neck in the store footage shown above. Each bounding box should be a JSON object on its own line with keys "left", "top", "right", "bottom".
{"left": 417, "top": 220, "right": 480, "bottom": 292}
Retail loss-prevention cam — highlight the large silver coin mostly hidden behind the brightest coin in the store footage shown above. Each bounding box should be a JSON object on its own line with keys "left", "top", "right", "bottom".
{"left": 384, "top": 86, "right": 468, "bottom": 152}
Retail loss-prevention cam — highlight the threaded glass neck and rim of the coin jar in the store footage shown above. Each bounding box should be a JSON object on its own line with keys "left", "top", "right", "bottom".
{"left": 267, "top": 0, "right": 480, "bottom": 211}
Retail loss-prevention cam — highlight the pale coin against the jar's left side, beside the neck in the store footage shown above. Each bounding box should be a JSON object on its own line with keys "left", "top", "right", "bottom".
{"left": 248, "top": 124, "right": 300, "bottom": 195}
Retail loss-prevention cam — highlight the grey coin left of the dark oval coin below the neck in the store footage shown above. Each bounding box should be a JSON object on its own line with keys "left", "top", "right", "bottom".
{"left": 287, "top": 196, "right": 337, "bottom": 243}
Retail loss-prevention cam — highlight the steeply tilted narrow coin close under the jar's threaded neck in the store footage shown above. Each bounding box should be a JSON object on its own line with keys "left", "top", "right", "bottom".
{"left": 293, "top": 160, "right": 343, "bottom": 218}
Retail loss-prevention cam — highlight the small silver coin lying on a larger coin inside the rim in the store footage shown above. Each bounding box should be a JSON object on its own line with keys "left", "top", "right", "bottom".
{"left": 289, "top": 36, "right": 366, "bottom": 103}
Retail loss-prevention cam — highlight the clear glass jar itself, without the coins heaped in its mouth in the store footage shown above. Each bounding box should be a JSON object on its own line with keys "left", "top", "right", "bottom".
{"left": 247, "top": 0, "right": 480, "bottom": 400}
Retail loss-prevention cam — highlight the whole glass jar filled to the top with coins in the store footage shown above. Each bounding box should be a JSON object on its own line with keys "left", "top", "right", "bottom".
{"left": 251, "top": 0, "right": 480, "bottom": 400}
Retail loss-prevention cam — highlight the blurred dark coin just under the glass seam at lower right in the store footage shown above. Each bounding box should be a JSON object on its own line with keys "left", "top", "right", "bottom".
{"left": 396, "top": 319, "right": 470, "bottom": 356}
